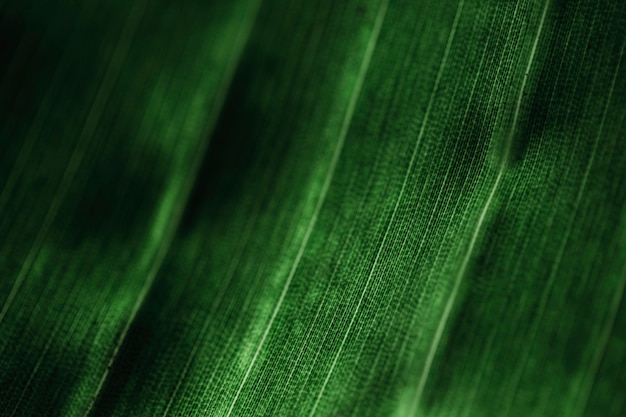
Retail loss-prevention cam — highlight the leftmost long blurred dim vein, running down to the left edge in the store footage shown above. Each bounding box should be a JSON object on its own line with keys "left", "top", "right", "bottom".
{"left": 0, "top": 0, "right": 146, "bottom": 323}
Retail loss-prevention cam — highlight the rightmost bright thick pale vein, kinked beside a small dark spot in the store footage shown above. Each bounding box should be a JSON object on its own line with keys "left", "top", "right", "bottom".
{"left": 409, "top": 0, "right": 550, "bottom": 415}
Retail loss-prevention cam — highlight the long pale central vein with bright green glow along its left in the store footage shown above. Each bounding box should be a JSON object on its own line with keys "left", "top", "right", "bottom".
{"left": 227, "top": 0, "right": 389, "bottom": 416}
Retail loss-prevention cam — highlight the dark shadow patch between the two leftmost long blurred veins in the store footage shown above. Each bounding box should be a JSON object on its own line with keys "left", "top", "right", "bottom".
{"left": 54, "top": 140, "right": 167, "bottom": 251}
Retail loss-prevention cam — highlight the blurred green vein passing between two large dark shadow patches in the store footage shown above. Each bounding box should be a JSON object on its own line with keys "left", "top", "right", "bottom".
{"left": 84, "top": 3, "right": 260, "bottom": 417}
